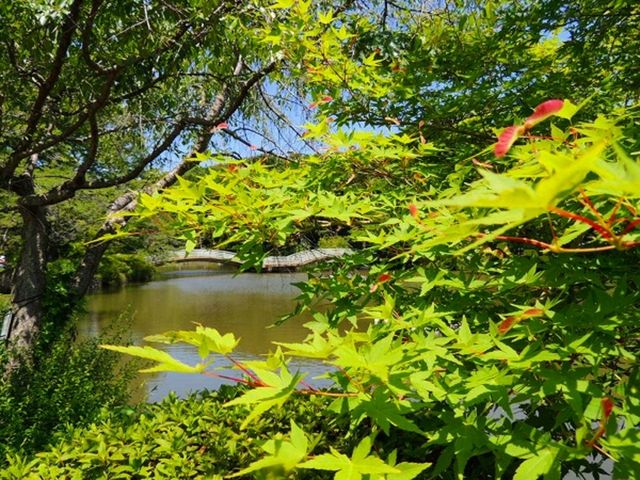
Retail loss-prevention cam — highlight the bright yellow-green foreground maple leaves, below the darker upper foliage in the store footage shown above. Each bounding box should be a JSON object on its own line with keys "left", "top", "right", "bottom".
{"left": 109, "top": 102, "right": 640, "bottom": 478}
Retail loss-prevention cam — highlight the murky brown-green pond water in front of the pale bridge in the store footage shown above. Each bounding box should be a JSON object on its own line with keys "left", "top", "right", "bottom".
{"left": 80, "top": 264, "right": 328, "bottom": 402}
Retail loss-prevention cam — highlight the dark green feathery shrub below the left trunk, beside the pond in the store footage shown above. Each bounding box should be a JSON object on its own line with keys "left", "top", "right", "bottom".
{"left": 0, "top": 318, "right": 133, "bottom": 463}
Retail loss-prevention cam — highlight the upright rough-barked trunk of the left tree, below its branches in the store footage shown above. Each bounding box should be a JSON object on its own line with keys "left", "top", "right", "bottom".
{"left": 8, "top": 206, "right": 48, "bottom": 370}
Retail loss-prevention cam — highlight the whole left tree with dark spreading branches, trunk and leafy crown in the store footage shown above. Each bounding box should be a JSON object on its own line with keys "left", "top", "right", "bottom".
{"left": 0, "top": 0, "right": 304, "bottom": 360}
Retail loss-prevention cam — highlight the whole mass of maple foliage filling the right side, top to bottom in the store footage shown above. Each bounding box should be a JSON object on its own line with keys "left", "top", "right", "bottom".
{"left": 104, "top": 2, "right": 640, "bottom": 479}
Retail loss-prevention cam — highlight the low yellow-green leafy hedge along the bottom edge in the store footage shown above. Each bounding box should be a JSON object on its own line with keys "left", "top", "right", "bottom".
{"left": 0, "top": 387, "right": 368, "bottom": 480}
